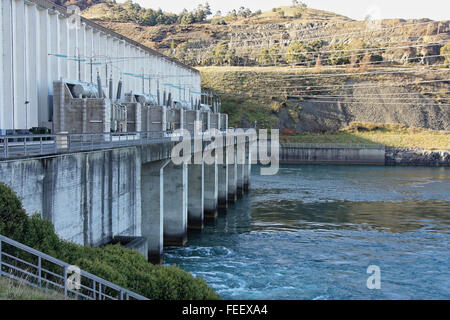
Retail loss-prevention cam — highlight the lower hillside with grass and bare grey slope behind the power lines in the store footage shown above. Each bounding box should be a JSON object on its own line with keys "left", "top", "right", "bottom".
{"left": 199, "top": 67, "right": 450, "bottom": 132}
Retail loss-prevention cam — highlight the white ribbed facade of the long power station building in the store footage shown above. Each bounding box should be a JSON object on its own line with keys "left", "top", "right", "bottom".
{"left": 0, "top": 0, "right": 201, "bottom": 134}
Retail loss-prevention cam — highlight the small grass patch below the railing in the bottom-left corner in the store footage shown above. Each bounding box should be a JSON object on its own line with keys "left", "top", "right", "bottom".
{"left": 0, "top": 277, "right": 64, "bottom": 300}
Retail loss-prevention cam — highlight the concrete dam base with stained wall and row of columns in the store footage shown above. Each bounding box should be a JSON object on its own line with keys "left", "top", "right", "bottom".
{"left": 0, "top": 116, "right": 251, "bottom": 262}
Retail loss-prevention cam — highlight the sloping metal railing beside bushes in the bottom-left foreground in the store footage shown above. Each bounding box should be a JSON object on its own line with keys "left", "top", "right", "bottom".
{"left": 0, "top": 235, "right": 148, "bottom": 300}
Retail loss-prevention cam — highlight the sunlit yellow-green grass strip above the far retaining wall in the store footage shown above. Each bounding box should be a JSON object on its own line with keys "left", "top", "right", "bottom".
{"left": 280, "top": 124, "right": 450, "bottom": 150}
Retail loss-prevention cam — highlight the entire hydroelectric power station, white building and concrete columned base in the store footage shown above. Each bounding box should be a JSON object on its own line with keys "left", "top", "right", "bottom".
{"left": 0, "top": 0, "right": 252, "bottom": 262}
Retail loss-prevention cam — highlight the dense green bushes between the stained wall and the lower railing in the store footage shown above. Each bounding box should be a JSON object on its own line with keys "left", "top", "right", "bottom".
{"left": 0, "top": 183, "right": 220, "bottom": 300}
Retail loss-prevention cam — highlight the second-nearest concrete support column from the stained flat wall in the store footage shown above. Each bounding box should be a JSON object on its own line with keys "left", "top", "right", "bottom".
{"left": 164, "top": 162, "right": 187, "bottom": 246}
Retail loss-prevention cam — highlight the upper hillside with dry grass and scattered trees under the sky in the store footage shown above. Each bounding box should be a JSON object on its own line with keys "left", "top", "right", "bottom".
{"left": 79, "top": 2, "right": 450, "bottom": 66}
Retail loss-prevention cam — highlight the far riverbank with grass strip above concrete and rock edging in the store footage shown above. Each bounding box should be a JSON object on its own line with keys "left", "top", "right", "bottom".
{"left": 280, "top": 122, "right": 450, "bottom": 167}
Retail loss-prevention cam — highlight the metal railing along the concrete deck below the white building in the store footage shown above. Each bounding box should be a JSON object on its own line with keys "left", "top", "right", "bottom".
{"left": 0, "top": 131, "right": 171, "bottom": 159}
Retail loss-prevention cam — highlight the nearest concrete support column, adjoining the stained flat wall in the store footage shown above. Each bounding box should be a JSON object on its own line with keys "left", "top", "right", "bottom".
{"left": 141, "top": 160, "right": 168, "bottom": 264}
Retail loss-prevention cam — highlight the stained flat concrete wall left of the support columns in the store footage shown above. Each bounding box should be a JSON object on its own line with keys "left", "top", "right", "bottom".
{"left": 0, "top": 148, "right": 141, "bottom": 246}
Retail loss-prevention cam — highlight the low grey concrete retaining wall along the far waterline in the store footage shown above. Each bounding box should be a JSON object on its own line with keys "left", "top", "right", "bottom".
{"left": 280, "top": 144, "right": 385, "bottom": 165}
